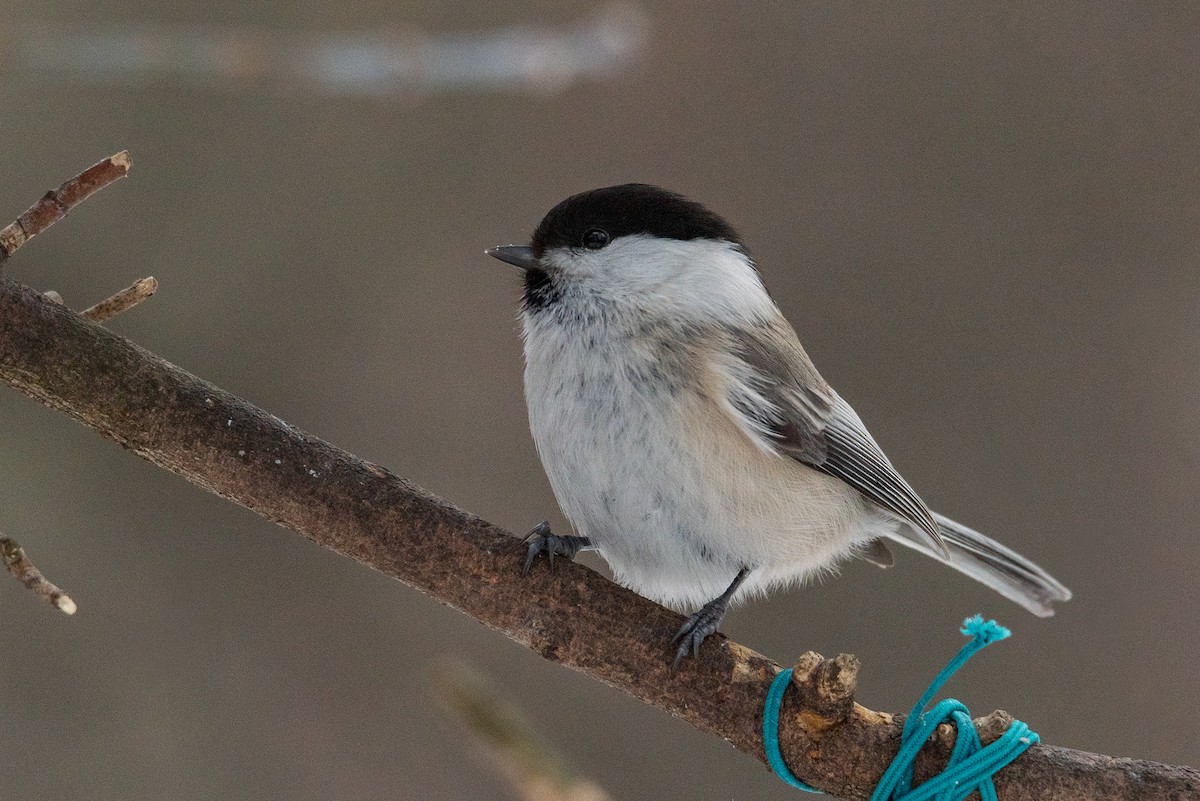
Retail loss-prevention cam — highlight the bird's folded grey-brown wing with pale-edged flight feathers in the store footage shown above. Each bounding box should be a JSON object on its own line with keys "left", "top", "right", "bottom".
{"left": 730, "top": 318, "right": 947, "bottom": 554}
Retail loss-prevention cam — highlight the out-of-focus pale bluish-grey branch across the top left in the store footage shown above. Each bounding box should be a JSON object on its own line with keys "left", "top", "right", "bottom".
{"left": 0, "top": 2, "right": 649, "bottom": 96}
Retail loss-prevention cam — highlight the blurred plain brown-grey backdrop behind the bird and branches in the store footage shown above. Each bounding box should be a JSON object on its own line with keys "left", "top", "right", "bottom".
{"left": 0, "top": 0, "right": 1200, "bottom": 801}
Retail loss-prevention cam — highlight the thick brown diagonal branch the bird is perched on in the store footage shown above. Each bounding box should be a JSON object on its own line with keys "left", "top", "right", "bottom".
{"left": 0, "top": 155, "right": 1200, "bottom": 801}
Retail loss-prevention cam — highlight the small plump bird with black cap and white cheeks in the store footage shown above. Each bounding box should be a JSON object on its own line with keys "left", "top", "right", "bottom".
{"left": 486, "top": 183, "right": 1070, "bottom": 668}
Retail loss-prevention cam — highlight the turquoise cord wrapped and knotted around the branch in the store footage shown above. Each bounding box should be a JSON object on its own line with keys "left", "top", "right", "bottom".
{"left": 762, "top": 615, "right": 1039, "bottom": 801}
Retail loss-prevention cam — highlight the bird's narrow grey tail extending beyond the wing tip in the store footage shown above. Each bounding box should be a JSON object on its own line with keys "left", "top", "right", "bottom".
{"left": 890, "top": 513, "right": 1070, "bottom": 618}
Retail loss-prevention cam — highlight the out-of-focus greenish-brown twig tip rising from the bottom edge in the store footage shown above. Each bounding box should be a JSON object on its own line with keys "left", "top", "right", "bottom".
{"left": 433, "top": 664, "right": 610, "bottom": 801}
